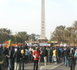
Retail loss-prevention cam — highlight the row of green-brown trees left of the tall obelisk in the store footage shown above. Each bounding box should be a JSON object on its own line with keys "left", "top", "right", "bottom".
{"left": 0, "top": 28, "right": 36, "bottom": 43}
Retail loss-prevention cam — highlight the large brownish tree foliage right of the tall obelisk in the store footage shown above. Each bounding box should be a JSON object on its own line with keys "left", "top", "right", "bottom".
{"left": 51, "top": 21, "right": 77, "bottom": 44}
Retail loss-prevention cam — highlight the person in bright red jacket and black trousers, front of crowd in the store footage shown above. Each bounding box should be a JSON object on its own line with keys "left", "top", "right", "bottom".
{"left": 33, "top": 47, "right": 40, "bottom": 70}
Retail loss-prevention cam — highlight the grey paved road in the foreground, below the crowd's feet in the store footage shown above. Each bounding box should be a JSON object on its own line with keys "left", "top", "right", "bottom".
{"left": 24, "top": 63, "right": 77, "bottom": 70}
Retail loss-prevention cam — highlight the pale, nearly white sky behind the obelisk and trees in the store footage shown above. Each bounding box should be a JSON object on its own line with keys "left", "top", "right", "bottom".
{"left": 0, "top": 0, "right": 77, "bottom": 39}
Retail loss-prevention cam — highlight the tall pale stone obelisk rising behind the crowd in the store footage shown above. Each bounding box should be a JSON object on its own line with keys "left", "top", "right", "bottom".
{"left": 40, "top": 0, "right": 46, "bottom": 40}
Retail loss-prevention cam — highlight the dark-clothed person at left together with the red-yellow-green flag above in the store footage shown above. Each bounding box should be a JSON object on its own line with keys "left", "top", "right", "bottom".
{"left": 4, "top": 40, "right": 12, "bottom": 70}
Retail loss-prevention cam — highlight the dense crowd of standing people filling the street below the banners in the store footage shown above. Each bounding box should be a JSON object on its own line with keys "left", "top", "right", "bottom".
{"left": 0, "top": 45, "right": 77, "bottom": 70}
